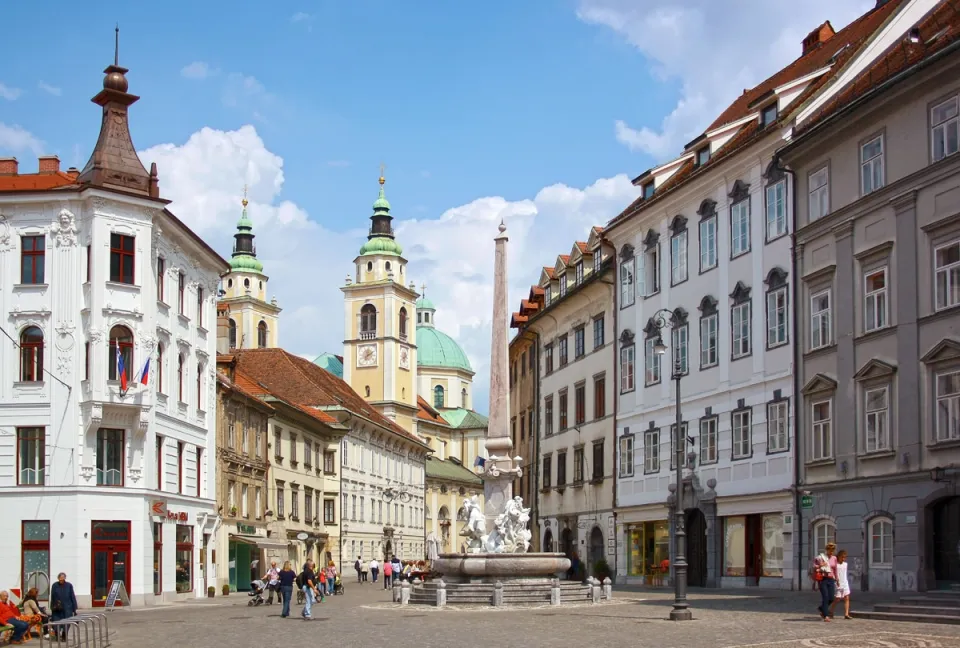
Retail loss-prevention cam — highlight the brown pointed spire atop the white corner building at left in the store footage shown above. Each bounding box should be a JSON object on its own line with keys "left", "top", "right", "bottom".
{"left": 78, "top": 26, "right": 159, "bottom": 198}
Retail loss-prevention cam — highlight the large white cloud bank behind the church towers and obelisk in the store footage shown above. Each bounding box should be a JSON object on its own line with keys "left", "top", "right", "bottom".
{"left": 140, "top": 126, "right": 637, "bottom": 406}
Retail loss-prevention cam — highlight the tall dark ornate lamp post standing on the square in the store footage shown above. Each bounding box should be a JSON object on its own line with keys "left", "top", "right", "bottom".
{"left": 650, "top": 308, "right": 693, "bottom": 621}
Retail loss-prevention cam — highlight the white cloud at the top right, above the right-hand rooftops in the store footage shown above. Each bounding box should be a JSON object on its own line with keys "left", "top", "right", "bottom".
{"left": 577, "top": 0, "right": 875, "bottom": 161}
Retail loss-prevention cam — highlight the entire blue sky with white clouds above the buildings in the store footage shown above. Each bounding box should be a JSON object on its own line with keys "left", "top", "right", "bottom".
{"left": 0, "top": 0, "right": 874, "bottom": 411}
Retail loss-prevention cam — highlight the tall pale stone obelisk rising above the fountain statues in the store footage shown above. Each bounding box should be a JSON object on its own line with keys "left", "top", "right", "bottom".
{"left": 483, "top": 221, "right": 517, "bottom": 529}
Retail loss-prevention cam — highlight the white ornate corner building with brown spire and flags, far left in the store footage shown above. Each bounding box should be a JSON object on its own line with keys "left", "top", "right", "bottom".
{"left": 0, "top": 55, "right": 227, "bottom": 607}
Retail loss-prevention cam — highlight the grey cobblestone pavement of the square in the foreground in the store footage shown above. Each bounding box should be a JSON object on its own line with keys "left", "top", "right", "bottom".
{"left": 95, "top": 583, "right": 960, "bottom": 648}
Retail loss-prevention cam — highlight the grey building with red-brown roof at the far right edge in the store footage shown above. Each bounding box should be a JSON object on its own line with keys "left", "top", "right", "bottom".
{"left": 779, "top": 2, "right": 960, "bottom": 591}
